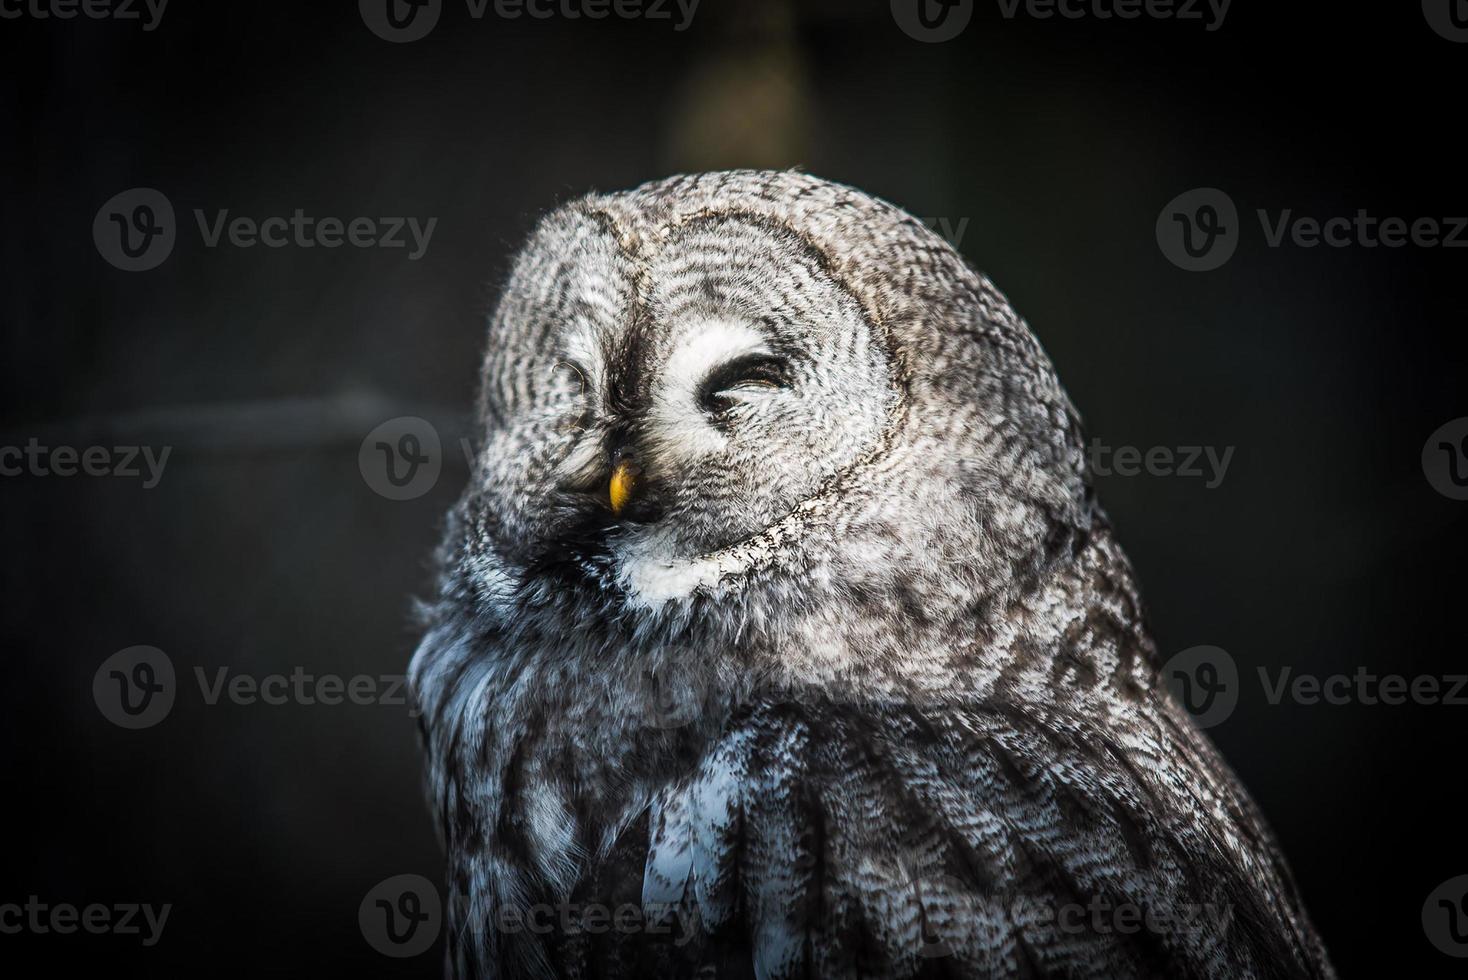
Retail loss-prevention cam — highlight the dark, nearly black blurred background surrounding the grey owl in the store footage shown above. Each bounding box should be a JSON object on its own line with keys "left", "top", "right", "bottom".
{"left": 0, "top": 0, "right": 1468, "bottom": 977}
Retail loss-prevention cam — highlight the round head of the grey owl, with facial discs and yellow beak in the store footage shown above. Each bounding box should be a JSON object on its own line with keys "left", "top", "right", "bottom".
{"left": 448, "top": 172, "right": 1091, "bottom": 642}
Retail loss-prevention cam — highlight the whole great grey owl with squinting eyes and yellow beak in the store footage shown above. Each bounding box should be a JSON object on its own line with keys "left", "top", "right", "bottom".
{"left": 411, "top": 172, "right": 1333, "bottom": 979}
